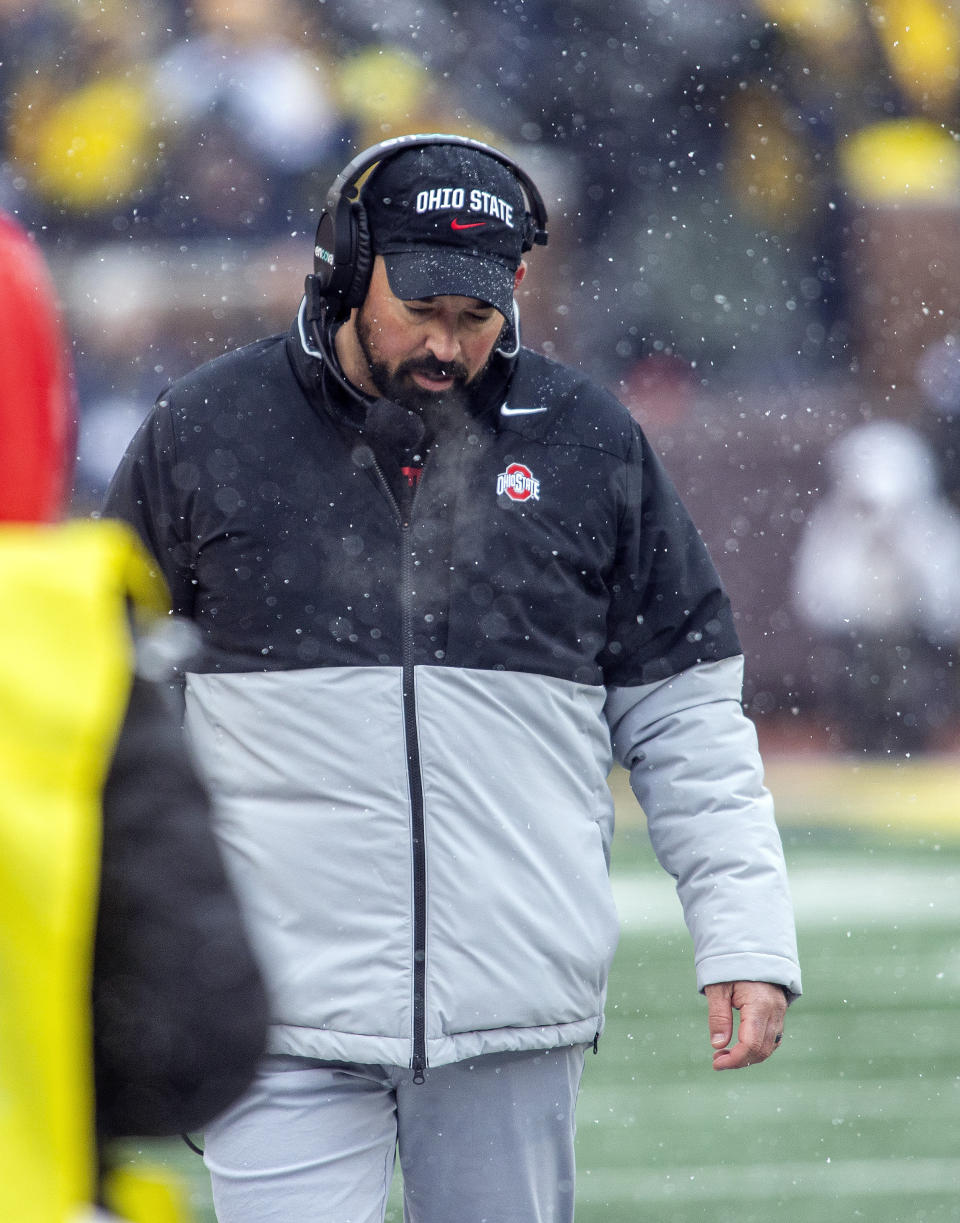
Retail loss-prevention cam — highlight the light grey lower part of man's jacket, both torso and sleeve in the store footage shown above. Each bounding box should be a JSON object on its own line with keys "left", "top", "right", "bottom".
{"left": 187, "top": 660, "right": 800, "bottom": 1065}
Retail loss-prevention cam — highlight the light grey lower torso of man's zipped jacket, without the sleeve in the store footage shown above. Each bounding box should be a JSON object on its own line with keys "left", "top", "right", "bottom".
{"left": 187, "top": 667, "right": 618, "bottom": 1065}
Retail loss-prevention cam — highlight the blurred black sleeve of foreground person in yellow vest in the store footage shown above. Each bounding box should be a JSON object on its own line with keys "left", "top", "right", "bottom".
{"left": 93, "top": 660, "right": 268, "bottom": 1139}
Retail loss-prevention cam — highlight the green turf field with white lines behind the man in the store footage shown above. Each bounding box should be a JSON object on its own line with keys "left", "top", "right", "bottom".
{"left": 116, "top": 763, "right": 960, "bottom": 1223}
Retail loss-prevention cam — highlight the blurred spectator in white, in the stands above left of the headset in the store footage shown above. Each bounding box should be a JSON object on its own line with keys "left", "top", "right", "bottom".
{"left": 150, "top": 0, "right": 349, "bottom": 238}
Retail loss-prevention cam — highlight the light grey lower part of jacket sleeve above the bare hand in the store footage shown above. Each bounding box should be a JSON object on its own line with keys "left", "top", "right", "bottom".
{"left": 605, "top": 657, "right": 801, "bottom": 999}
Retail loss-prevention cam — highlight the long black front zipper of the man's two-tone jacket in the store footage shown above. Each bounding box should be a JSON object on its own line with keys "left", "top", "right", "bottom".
{"left": 373, "top": 459, "right": 427, "bottom": 1084}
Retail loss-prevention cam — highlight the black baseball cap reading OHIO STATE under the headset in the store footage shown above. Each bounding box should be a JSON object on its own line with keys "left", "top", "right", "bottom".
{"left": 362, "top": 144, "right": 532, "bottom": 319}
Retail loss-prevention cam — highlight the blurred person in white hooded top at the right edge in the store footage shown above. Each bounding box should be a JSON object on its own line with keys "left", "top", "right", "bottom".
{"left": 794, "top": 421, "right": 960, "bottom": 755}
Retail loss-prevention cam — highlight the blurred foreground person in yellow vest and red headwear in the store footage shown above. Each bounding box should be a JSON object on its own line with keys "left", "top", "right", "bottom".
{"left": 0, "top": 214, "right": 267, "bottom": 1223}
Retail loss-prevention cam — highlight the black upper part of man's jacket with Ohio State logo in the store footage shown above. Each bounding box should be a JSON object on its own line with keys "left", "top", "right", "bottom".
{"left": 106, "top": 325, "right": 740, "bottom": 684}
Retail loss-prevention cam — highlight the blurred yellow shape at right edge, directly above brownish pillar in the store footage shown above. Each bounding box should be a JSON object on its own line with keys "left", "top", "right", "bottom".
{"left": 838, "top": 119, "right": 960, "bottom": 205}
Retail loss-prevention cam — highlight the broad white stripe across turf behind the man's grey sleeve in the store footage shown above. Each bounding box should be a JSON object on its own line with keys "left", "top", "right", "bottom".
{"left": 613, "top": 861, "right": 960, "bottom": 933}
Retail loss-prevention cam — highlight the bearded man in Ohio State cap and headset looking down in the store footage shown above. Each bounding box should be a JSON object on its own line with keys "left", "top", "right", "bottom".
{"left": 108, "top": 136, "right": 800, "bottom": 1223}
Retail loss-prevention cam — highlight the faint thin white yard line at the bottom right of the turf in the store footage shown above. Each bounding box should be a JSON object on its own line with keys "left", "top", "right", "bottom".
{"left": 577, "top": 1159, "right": 960, "bottom": 1206}
